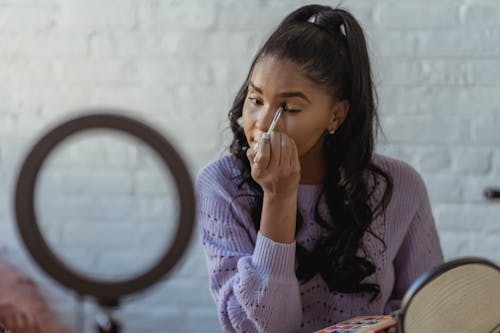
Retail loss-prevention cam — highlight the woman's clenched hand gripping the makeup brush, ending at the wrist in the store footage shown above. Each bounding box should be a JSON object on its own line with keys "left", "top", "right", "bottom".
{"left": 247, "top": 132, "right": 300, "bottom": 198}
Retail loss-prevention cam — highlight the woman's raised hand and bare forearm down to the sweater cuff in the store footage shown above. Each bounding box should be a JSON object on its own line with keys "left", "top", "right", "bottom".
{"left": 247, "top": 132, "right": 300, "bottom": 243}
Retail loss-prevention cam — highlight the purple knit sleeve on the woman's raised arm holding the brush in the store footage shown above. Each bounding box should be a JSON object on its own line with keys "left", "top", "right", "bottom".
{"left": 197, "top": 160, "right": 302, "bottom": 333}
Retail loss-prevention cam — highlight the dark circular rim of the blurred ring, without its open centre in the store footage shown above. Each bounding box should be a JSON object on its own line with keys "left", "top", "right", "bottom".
{"left": 15, "top": 109, "right": 195, "bottom": 306}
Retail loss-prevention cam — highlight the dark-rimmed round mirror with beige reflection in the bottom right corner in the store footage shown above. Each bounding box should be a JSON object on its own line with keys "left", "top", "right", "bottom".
{"left": 399, "top": 258, "right": 500, "bottom": 333}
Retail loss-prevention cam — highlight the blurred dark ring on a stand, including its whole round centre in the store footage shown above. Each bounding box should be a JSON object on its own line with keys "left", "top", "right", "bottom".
{"left": 16, "top": 114, "right": 194, "bottom": 305}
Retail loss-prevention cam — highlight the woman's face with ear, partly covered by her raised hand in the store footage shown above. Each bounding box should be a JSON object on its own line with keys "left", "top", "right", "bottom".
{"left": 243, "top": 56, "right": 349, "bottom": 159}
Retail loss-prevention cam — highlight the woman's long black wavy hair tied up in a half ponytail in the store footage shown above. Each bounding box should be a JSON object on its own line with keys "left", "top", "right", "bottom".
{"left": 228, "top": 5, "right": 393, "bottom": 300}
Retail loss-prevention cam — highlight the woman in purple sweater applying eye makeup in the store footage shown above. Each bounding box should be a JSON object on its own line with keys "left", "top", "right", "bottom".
{"left": 197, "top": 5, "right": 442, "bottom": 332}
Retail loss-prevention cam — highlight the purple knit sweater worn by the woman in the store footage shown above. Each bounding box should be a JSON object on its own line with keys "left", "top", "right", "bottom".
{"left": 196, "top": 155, "right": 443, "bottom": 333}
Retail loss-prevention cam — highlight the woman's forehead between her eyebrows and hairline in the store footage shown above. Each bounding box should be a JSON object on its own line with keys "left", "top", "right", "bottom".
{"left": 250, "top": 55, "right": 318, "bottom": 92}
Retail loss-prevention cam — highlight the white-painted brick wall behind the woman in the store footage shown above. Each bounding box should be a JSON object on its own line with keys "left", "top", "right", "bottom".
{"left": 0, "top": 0, "right": 500, "bottom": 332}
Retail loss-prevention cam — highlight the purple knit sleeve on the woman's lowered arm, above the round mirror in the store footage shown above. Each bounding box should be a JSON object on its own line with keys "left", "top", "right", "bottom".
{"left": 385, "top": 170, "right": 443, "bottom": 313}
